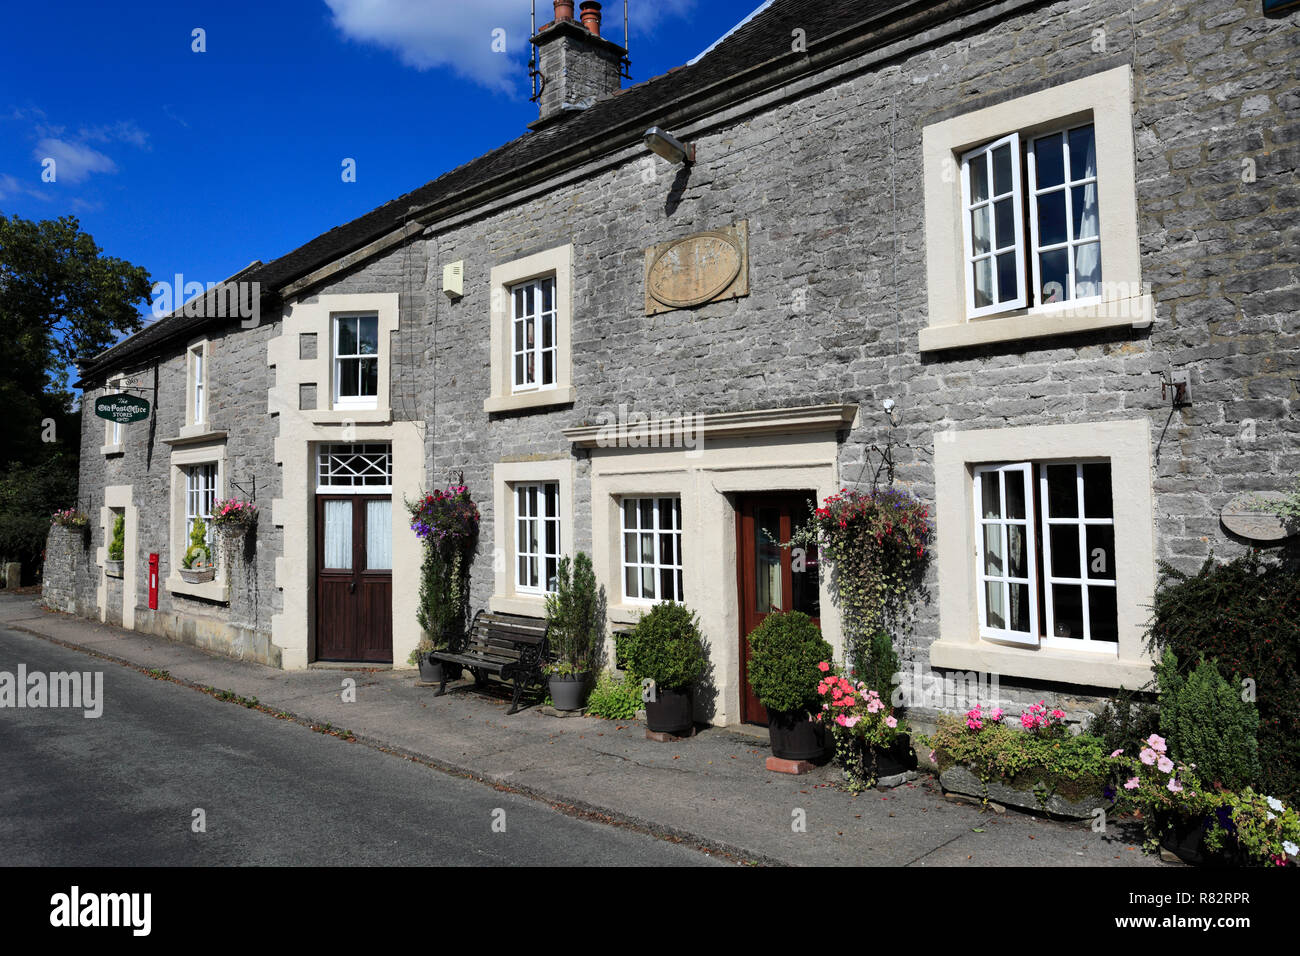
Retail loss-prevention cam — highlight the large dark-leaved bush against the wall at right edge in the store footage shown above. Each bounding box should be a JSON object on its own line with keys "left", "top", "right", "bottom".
{"left": 1148, "top": 551, "right": 1300, "bottom": 804}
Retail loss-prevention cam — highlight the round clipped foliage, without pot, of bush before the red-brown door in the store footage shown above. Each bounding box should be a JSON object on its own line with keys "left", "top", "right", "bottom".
{"left": 746, "top": 611, "right": 835, "bottom": 713}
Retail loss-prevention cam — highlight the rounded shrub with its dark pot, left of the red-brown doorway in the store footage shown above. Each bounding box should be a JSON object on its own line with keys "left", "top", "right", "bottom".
{"left": 623, "top": 601, "right": 709, "bottom": 734}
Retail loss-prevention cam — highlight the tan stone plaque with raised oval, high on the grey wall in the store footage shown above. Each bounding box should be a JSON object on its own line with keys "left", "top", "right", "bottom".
{"left": 646, "top": 220, "right": 749, "bottom": 315}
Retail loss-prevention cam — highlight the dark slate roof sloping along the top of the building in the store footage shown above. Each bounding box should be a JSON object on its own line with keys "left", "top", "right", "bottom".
{"left": 78, "top": 0, "right": 925, "bottom": 385}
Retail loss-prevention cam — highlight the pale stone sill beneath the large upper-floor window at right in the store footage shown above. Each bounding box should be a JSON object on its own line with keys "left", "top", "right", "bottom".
{"left": 918, "top": 295, "right": 1156, "bottom": 352}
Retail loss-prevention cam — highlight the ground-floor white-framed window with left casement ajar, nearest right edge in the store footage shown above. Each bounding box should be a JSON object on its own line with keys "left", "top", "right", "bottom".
{"left": 974, "top": 460, "right": 1119, "bottom": 653}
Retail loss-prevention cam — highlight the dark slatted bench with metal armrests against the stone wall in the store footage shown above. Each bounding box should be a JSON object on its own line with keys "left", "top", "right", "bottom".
{"left": 430, "top": 610, "right": 550, "bottom": 714}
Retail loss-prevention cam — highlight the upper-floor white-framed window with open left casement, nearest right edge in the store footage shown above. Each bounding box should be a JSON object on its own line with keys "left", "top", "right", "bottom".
{"left": 962, "top": 122, "right": 1101, "bottom": 319}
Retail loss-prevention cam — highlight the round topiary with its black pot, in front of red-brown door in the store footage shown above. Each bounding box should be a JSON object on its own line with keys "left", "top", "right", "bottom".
{"left": 748, "top": 611, "right": 832, "bottom": 760}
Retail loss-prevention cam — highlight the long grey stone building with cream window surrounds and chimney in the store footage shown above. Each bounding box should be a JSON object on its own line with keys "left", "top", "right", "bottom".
{"left": 51, "top": 0, "right": 1300, "bottom": 723}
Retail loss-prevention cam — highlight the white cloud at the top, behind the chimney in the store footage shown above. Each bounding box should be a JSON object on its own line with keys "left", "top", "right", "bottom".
{"left": 325, "top": 0, "right": 696, "bottom": 92}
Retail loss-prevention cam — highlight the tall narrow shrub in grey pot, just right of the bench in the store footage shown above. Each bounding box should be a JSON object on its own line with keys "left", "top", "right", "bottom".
{"left": 546, "top": 551, "right": 603, "bottom": 710}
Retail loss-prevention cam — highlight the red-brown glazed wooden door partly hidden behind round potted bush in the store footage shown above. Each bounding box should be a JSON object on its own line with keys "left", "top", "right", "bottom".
{"left": 736, "top": 492, "right": 822, "bottom": 724}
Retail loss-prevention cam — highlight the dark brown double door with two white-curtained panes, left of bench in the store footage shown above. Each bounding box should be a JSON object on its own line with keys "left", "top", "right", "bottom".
{"left": 316, "top": 494, "right": 393, "bottom": 663}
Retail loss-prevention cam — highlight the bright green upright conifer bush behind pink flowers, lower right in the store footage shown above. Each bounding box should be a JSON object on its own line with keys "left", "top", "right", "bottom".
{"left": 1158, "top": 649, "right": 1260, "bottom": 790}
